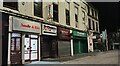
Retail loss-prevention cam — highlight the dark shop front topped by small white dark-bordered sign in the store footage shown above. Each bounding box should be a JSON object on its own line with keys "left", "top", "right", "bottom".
{"left": 41, "top": 24, "right": 57, "bottom": 59}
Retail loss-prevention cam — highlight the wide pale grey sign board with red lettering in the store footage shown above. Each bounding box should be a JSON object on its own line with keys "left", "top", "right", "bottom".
{"left": 12, "top": 17, "right": 41, "bottom": 33}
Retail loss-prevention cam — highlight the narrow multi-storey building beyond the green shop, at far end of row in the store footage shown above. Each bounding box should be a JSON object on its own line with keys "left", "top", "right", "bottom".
{"left": 87, "top": 3, "right": 101, "bottom": 52}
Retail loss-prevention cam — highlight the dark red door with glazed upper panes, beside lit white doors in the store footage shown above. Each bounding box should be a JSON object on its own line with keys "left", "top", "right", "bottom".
{"left": 10, "top": 33, "right": 21, "bottom": 64}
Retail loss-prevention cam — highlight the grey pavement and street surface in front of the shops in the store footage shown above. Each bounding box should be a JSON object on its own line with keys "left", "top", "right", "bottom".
{"left": 26, "top": 50, "right": 118, "bottom": 65}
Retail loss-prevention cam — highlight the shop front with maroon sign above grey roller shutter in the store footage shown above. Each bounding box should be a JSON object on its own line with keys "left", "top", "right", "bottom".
{"left": 58, "top": 27, "right": 71, "bottom": 57}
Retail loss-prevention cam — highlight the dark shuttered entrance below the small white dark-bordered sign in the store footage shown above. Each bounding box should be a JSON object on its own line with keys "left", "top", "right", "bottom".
{"left": 41, "top": 36, "right": 57, "bottom": 59}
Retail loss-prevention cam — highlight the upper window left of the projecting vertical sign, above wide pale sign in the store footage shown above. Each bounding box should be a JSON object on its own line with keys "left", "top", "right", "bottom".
{"left": 34, "top": 0, "right": 43, "bottom": 17}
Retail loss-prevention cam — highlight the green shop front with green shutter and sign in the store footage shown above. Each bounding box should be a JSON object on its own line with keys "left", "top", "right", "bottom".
{"left": 72, "top": 30, "right": 88, "bottom": 54}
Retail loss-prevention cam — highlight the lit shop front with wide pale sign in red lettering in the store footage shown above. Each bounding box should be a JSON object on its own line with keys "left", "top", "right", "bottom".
{"left": 8, "top": 16, "right": 41, "bottom": 64}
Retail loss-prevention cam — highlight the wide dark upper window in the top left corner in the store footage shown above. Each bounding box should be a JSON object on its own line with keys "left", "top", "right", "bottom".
{"left": 3, "top": 0, "right": 18, "bottom": 10}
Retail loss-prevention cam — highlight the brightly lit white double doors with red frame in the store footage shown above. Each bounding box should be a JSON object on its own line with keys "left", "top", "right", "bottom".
{"left": 24, "top": 35, "right": 38, "bottom": 62}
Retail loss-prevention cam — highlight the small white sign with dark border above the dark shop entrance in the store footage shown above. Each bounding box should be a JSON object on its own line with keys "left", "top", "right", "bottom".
{"left": 42, "top": 24, "right": 57, "bottom": 36}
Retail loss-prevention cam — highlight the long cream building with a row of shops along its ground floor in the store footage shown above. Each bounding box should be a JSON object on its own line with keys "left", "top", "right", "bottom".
{"left": 0, "top": 0, "right": 99, "bottom": 64}
